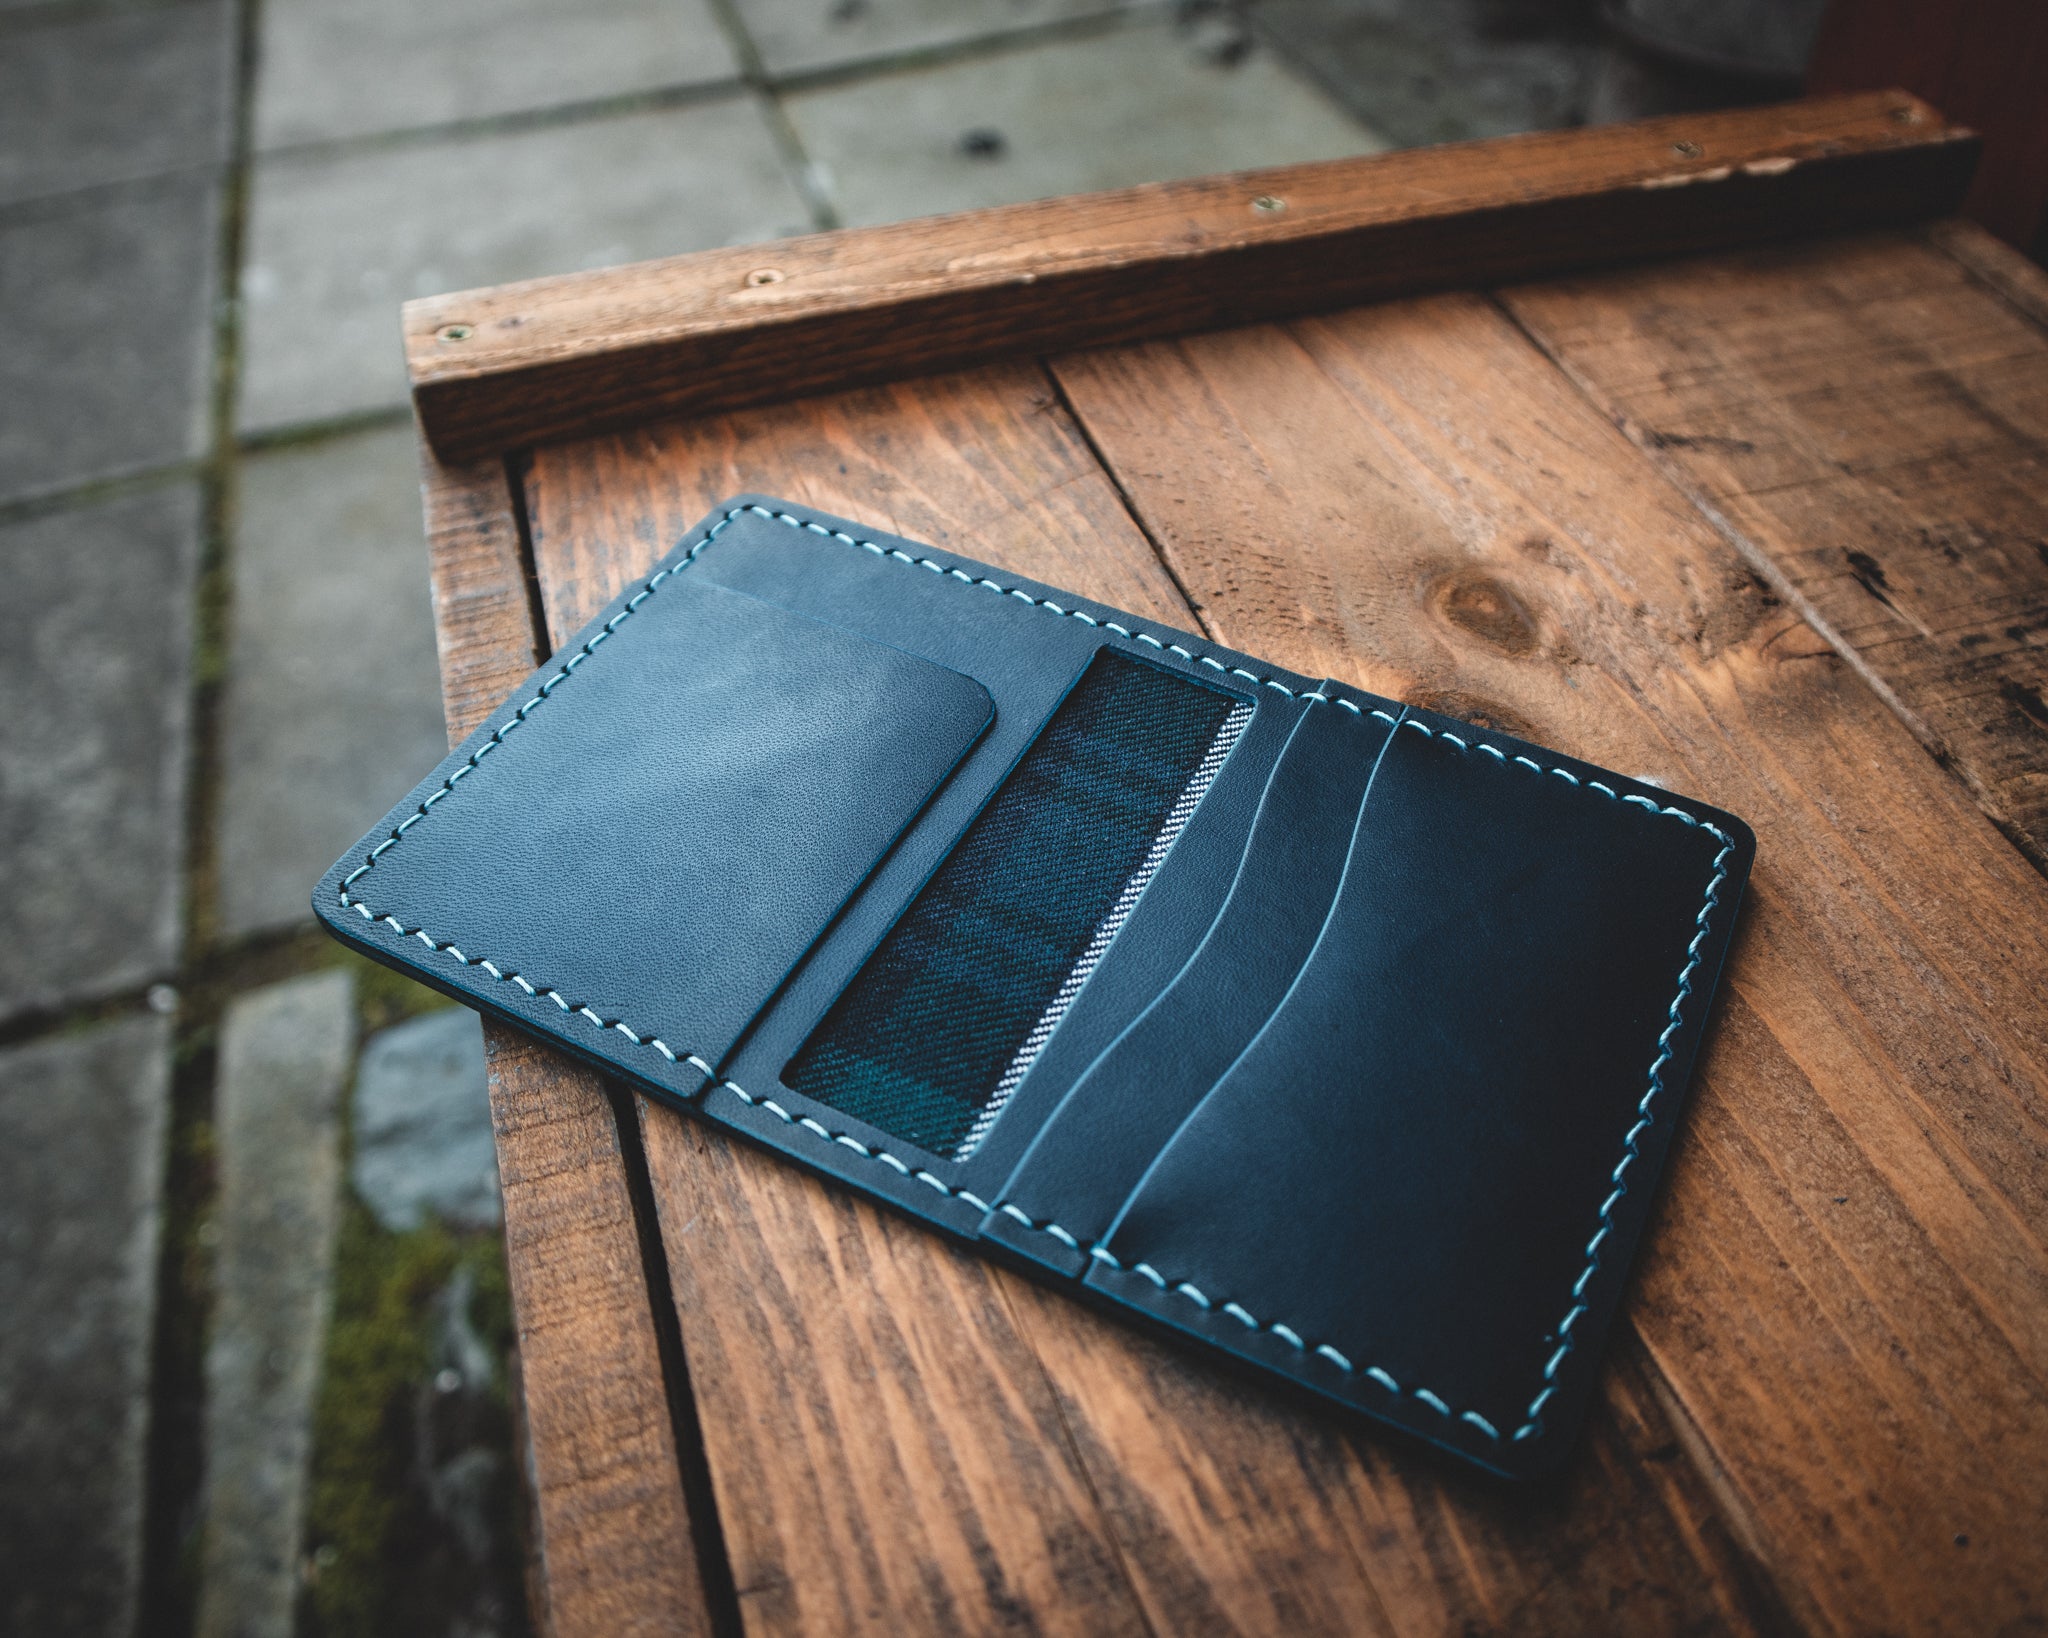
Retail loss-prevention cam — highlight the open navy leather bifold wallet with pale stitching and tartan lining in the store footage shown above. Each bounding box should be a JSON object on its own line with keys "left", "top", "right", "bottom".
{"left": 313, "top": 498, "right": 1755, "bottom": 1476}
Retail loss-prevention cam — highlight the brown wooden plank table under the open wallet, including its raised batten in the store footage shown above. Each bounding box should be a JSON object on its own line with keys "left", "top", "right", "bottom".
{"left": 406, "top": 94, "right": 2048, "bottom": 1638}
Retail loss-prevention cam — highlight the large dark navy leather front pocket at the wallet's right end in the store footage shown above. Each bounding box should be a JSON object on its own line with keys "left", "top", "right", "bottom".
{"left": 1075, "top": 717, "right": 1749, "bottom": 1466}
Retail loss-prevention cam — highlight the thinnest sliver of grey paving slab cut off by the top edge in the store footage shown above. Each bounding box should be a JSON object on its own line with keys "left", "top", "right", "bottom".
{"left": 735, "top": 0, "right": 1124, "bottom": 74}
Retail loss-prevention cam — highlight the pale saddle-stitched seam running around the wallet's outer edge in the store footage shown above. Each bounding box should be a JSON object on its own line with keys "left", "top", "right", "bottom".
{"left": 340, "top": 504, "right": 1735, "bottom": 1441}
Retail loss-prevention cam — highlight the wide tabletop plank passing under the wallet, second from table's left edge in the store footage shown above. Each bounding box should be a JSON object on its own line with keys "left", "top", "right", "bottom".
{"left": 528, "top": 367, "right": 1769, "bottom": 1634}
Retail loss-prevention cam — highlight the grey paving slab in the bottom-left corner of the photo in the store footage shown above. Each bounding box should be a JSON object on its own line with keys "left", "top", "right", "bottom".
{"left": 0, "top": 1018, "right": 170, "bottom": 1638}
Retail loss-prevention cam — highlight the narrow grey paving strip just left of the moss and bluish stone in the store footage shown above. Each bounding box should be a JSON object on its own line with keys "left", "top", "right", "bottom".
{"left": 197, "top": 971, "right": 356, "bottom": 1638}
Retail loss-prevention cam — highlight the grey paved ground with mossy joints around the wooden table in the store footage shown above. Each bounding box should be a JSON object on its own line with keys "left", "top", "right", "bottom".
{"left": 0, "top": 0, "right": 1777, "bottom": 1636}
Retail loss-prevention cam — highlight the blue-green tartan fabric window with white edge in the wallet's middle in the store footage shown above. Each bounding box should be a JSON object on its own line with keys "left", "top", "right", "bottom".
{"left": 782, "top": 649, "right": 1251, "bottom": 1159}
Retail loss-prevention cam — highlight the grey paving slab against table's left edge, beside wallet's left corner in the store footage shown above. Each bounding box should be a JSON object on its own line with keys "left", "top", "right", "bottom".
{"left": 217, "top": 426, "right": 449, "bottom": 936}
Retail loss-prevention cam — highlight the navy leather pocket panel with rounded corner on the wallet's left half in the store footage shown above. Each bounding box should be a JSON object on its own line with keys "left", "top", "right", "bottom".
{"left": 315, "top": 573, "right": 993, "bottom": 1071}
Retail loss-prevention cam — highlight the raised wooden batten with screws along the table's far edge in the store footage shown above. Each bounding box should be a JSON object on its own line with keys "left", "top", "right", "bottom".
{"left": 403, "top": 92, "right": 1976, "bottom": 459}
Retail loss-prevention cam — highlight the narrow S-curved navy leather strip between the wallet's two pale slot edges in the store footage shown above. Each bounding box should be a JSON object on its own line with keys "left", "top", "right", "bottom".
{"left": 983, "top": 690, "right": 1393, "bottom": 1265}
